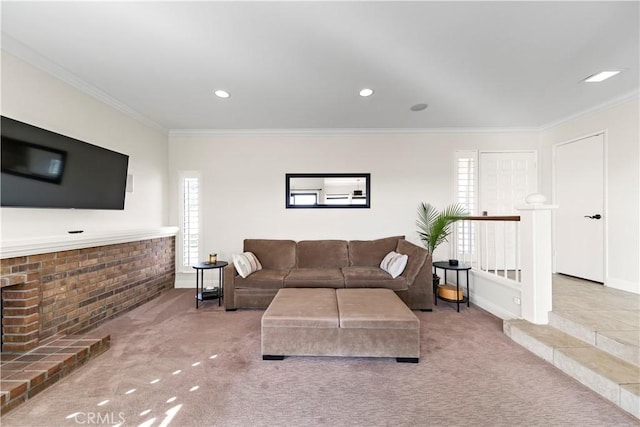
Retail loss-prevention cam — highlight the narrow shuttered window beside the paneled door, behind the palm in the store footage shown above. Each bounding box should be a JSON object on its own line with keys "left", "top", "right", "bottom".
{"left": 456, "top": 151, "right": 478, "bottom": 255}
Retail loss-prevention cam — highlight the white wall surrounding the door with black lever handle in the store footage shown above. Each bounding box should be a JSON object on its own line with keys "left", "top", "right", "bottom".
{"left": 541, "top": 97, "right": 640, "bottom": 293}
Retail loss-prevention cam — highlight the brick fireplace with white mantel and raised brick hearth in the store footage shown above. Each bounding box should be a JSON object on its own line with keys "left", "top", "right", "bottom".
{"left": 0, "top": 231, "right": 175, "bottom": 415}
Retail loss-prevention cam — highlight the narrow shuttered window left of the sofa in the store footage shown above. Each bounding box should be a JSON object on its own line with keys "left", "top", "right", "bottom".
{"left": 179, "top": 171, "right": 201, "bottom": 272}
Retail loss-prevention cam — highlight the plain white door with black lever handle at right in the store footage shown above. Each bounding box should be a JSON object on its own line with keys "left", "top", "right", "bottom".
{"left": 554, "top": 134, "right": 605, "bottom": 283}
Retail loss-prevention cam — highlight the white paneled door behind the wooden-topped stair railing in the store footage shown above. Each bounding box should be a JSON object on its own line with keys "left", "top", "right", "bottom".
{"left": 479, "top": 152, "right": 538, "bottom": 270}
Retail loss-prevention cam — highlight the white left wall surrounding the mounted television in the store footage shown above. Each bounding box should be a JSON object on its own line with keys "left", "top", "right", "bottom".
{"left": 0, "top": 51, "right": 168, "bottom": 241}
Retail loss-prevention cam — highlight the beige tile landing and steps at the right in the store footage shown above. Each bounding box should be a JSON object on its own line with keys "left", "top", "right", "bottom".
{"left": 505, "top": 275, "right": 640, "bottom": 419}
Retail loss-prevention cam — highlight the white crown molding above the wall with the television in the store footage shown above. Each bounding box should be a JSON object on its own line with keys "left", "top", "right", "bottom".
{"left": 2, "top": 33, "right": 168, "bottom": 134}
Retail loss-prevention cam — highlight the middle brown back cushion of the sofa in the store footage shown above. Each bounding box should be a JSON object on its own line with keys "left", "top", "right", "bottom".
{"left": 297, "top": 240, "right": 349, "bottom": 268}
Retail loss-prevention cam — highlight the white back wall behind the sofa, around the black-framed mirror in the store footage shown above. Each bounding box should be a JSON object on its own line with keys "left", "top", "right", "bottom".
{"left": 169, "top": 133, "right": 538, "bottom": 270}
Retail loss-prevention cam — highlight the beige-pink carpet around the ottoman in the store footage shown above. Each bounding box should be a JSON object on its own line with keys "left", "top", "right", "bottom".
{"left": 2, "top": 289, "right": 638, "bottom": 427}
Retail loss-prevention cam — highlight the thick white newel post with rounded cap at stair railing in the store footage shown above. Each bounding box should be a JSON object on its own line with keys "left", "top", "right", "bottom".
{"left": 516, "top": 194, "right": 557, "bottom": 325}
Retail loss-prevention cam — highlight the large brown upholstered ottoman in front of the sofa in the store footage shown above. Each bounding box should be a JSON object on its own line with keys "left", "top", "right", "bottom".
{"left": 262, "top": 288, "right": 420, "bottom": 363}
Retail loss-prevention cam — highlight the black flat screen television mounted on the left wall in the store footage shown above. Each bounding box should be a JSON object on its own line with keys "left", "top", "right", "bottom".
{"left": 0, "top": 116, "right": 129, "bottom": 210}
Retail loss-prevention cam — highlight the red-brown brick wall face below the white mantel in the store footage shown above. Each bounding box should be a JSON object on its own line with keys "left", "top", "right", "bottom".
{"left": 0, "top": 237, "right": 175, "bottom": 351}
